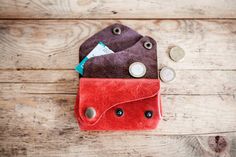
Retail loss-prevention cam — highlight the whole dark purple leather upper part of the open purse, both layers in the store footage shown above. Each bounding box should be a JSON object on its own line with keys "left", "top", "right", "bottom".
{"left": 79, "top": 24, "right": 158, "bottom": 78}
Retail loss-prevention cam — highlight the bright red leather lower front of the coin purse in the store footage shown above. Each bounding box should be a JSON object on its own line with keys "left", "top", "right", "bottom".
{"left": 75, "top": 78, "right": 162, "bottom": 130}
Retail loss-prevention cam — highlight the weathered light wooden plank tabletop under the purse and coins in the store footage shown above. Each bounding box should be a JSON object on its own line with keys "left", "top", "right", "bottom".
{"left": 0, "top": 0, "right": 236, "bottom": 157}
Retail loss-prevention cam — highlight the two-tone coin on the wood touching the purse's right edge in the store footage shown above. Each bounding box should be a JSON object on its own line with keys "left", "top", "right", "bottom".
{"left": 160, "top": 67, "right": 176, "bottom": 82}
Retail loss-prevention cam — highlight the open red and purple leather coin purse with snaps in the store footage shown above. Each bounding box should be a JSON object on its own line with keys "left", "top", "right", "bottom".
{"left": 75, "top": 24, "right": 162, "bottom": 130}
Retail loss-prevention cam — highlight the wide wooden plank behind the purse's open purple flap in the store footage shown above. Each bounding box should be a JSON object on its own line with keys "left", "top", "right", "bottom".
{"left": 0, "top": 20, "right": 236, "bottom": 70}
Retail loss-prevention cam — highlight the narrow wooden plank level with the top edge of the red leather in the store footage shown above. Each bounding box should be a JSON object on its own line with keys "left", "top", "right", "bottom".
{"left": 0, "top": 70, "right": 236, "bottom": 95}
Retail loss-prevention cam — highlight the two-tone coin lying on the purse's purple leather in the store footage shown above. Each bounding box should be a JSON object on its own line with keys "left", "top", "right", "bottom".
{"left": 129, "top": 62, "right": 147, "bottom": 77}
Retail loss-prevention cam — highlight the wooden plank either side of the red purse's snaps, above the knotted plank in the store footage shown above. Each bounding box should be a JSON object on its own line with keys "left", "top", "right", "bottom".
{"left": 0, "top": 94, "right": 236, "bottom": 134}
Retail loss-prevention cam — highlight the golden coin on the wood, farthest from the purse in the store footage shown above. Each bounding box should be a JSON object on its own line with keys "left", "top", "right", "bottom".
{"left": 169, "top": 46, "right": 185, "bottom": 62}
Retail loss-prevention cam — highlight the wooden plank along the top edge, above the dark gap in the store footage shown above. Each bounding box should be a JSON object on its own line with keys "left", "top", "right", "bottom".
{"left": 0, "top": 0, "right": 236, "bottom": 19}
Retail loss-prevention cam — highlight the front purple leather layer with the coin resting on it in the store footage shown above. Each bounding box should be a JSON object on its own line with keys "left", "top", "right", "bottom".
{"left": 83, "top": 37, "right": 158, "bottom": 78}
